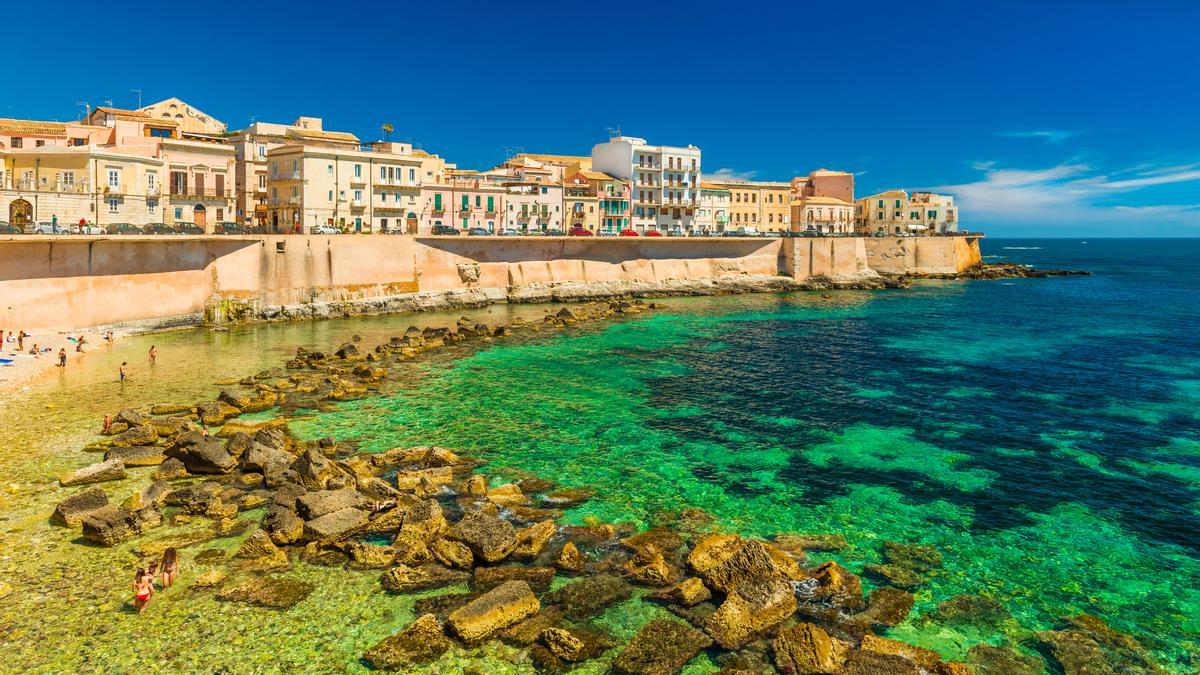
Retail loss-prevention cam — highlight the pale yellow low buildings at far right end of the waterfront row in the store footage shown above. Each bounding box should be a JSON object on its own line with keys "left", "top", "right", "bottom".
{"left": 854, "top": 190, "right": 959, "bottom": 235}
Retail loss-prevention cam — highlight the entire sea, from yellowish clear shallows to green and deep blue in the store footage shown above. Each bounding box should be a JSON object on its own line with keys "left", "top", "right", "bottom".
{"left": 0, "top": 240, "right": 1200, "bottom": 671}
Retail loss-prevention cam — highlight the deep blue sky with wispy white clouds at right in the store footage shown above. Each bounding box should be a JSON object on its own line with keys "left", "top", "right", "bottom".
{"left": 0, "top": 0, "right": 1200, "bottom": 237}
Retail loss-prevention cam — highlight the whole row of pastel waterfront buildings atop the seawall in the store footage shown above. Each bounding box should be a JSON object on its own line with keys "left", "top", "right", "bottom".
{"left": 0, "top": 98, "right": 958, "bottom": 234}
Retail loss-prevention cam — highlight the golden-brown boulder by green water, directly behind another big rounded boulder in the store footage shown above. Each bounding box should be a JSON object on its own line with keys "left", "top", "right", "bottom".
{"left": 688, "top": 534, "right": 806, "bottom": 593}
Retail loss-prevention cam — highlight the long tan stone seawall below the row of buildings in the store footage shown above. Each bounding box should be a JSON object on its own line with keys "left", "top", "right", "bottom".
{"left": 0, "top": 235, "right": 979, "bottom": 330}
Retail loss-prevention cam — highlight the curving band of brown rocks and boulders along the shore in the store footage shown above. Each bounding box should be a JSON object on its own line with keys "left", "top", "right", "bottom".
{"left": 52, "top": 300, "right": 1160, "bottom": 675}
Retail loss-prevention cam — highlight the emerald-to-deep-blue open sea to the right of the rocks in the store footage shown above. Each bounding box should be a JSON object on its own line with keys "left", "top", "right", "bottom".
{"left": 290, "top": 241, "right": 1200, "bottom": 664}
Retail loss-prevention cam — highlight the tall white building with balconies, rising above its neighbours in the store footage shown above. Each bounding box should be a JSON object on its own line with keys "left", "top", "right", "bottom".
{"left": 592, "top": 136, "right": 700, "bottom": 232}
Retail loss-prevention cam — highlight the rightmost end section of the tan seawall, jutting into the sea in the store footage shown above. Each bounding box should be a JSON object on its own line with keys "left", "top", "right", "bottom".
{"left": 863, "top": 237, "right": 983, "bottom": 274}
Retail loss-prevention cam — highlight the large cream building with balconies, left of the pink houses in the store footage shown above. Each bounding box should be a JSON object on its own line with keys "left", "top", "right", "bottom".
{"left": 266, "top": 142, "right": 424, "bottom": 233}
